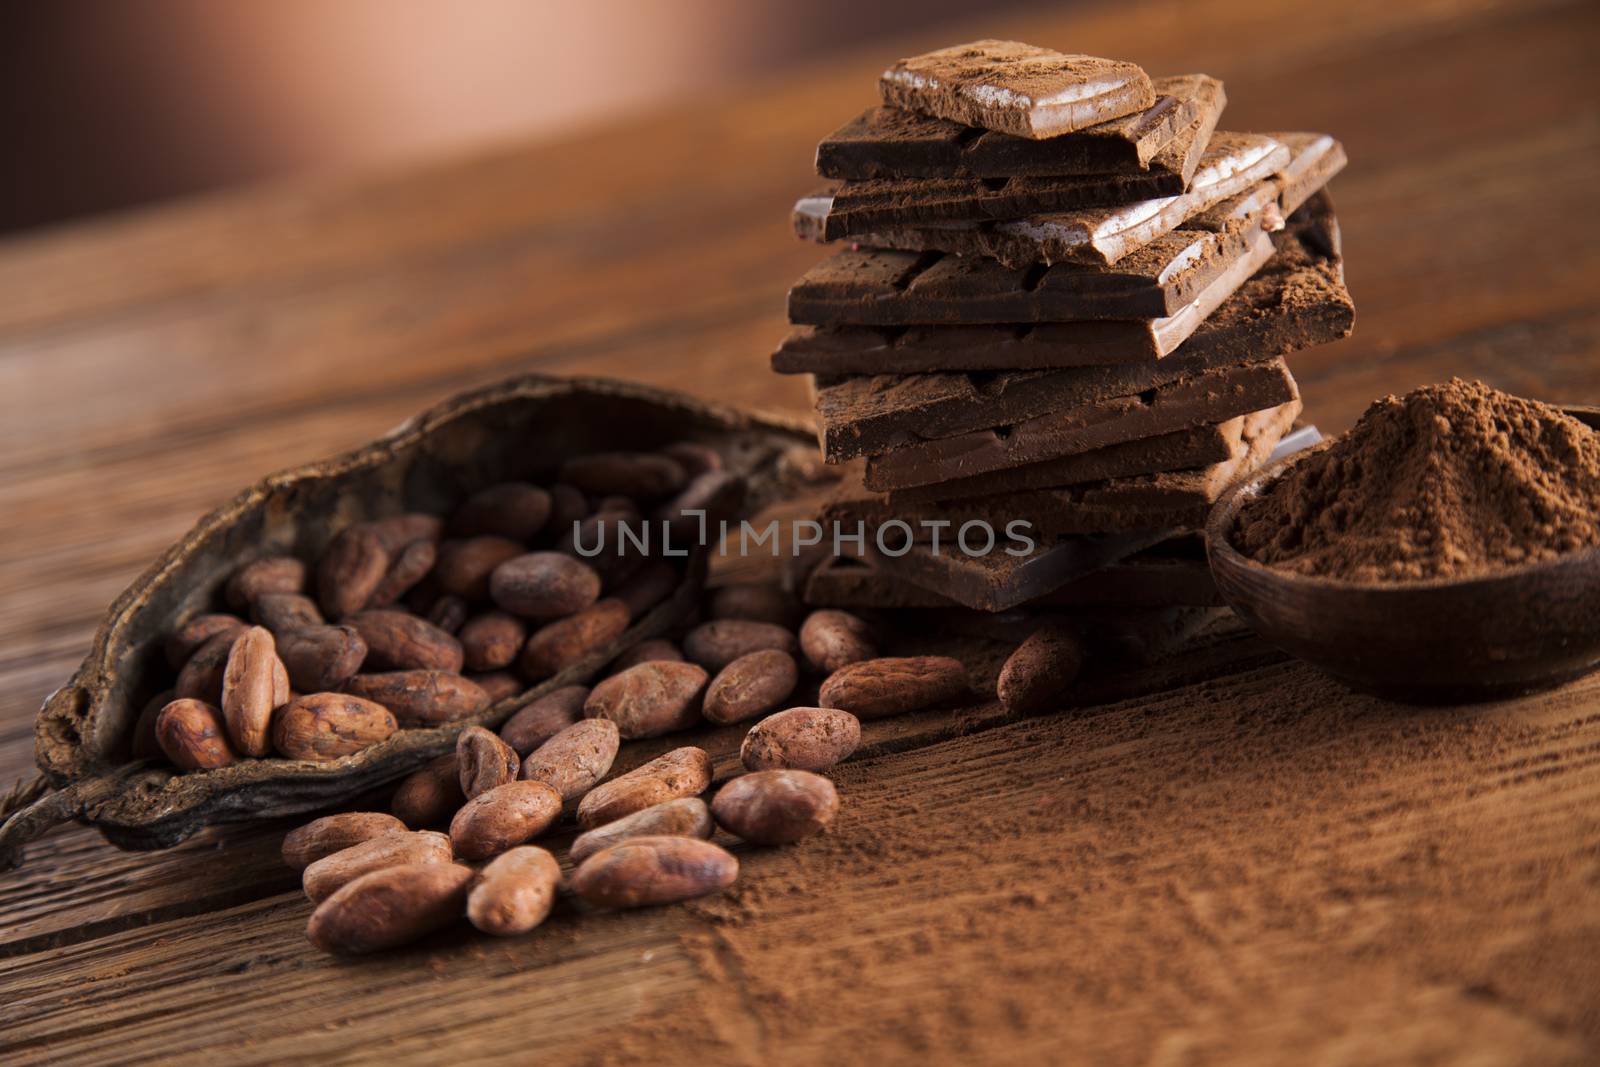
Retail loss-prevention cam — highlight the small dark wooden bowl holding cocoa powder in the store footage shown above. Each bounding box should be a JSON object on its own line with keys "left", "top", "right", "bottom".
{"left": 1206, "top": 408, "right": 1600, "bottom": 704}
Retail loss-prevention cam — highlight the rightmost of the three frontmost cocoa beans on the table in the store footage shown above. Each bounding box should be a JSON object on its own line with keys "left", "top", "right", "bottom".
{"left": 571, "top": 837, "right": 739, "bottom": 907}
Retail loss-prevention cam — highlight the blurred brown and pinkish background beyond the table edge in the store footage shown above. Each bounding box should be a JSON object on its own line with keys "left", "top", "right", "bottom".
{"left": 0, "top": 0, "right": 1064, "bottom": 232}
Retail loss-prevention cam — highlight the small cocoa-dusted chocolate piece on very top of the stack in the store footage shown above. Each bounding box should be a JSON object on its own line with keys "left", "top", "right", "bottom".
{"left": 878, "top": 40, "right": 1155, "bottom": 141}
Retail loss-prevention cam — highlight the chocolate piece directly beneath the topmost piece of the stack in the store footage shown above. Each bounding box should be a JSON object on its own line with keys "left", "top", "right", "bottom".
{"left": 816, "top": 74, "right": 1227, "bottom": 184}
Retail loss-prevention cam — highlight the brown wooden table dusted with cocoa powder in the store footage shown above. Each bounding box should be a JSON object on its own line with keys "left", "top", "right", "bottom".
{"left": 0, "top": 0, "right": 1600, "bottom": 1064}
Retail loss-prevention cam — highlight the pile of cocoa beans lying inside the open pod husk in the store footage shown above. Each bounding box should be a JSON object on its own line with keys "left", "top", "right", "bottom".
{"left": 133, "top": 442, "right": 744, "bottom": 771}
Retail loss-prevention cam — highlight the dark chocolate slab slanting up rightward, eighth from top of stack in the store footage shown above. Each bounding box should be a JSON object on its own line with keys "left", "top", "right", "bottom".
{"left": 866, "top": 360, "right": 1299, "bottom": 491}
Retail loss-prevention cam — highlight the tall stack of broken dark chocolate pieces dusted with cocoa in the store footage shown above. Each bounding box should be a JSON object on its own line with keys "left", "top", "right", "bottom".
{"left": 773, "top": 40, "right": 1355, "bottom": 643}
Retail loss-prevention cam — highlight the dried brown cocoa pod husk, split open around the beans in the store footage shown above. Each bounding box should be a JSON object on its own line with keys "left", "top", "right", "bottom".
{"left": 9, "top": 376, "right": 814, "bottom": 865}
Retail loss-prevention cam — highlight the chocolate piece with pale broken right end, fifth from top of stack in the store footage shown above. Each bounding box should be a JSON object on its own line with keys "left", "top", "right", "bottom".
{"left": 789, "top": 211, "right": 1260, "bottom": 326}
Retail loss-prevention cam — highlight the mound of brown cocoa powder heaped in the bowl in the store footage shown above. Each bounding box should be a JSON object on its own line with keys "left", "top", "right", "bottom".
{"left": 1234, "top": 378, "right": 1600, "bottom": 581}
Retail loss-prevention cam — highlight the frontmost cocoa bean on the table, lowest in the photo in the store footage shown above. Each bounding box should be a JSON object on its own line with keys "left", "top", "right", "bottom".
{"left": 306, "top": 864, "right": 474, "bottom": 955}
